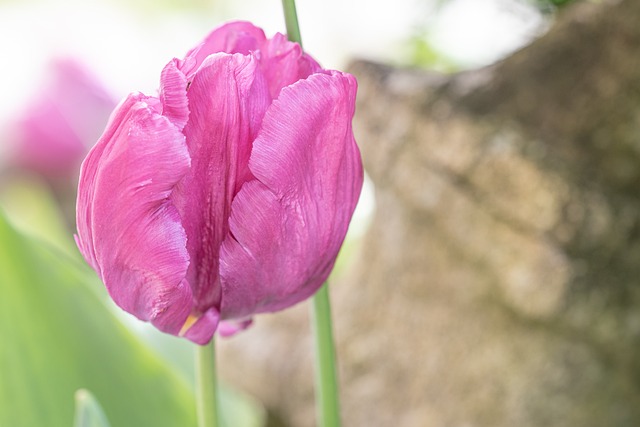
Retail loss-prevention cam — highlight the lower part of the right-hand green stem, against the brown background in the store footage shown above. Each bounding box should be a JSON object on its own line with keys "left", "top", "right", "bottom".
{"left": 311, "top": 283, "right": 340, "bottom": 427}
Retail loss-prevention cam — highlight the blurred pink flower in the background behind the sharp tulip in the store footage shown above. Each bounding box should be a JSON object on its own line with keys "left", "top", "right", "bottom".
{"left": 10, "top": 58, "right": 116, "bottom": 181}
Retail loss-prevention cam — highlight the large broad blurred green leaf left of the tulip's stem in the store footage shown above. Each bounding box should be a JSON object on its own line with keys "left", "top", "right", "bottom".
{"left": 0, "top": 212, "right": 196, "bottom": 427}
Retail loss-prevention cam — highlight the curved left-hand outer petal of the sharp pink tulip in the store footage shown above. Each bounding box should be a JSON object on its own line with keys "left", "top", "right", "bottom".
{"left": 76, "top": 94, "right": 192, "bottom": 334}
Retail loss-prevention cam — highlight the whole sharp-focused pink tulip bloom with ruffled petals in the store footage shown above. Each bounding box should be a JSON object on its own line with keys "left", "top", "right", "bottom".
{"left": 76, "top": 22, "right": 363, "bottom": 344}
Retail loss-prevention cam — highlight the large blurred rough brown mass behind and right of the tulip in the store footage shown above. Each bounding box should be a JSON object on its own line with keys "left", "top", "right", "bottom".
{"left": 221, "top": 0, "right": 640, "bottom": 427}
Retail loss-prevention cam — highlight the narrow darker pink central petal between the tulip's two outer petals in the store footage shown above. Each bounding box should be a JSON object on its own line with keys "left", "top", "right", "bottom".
{"left": 173, "top": 53, "right": 269, "bottom": 316}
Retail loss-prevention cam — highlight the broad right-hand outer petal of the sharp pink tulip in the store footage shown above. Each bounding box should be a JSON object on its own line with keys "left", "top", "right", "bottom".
{"left": 220, "top": 72, "right": 363, "bottom": 319}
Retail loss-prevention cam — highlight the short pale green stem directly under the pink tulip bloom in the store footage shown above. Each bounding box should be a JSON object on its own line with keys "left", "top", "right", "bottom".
{"left": 196, "top": 337, "right": 221, "bottom": 427}
